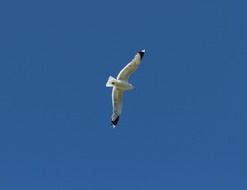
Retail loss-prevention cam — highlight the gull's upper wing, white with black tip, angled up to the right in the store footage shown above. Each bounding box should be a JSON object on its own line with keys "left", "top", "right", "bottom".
{"left": 117, "top": 50, "right": 145, "bottom": 81}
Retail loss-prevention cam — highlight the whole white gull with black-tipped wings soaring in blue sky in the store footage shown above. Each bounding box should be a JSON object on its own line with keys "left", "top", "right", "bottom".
{"left": 106, "top": 50, "right": 145, "bottom": 128}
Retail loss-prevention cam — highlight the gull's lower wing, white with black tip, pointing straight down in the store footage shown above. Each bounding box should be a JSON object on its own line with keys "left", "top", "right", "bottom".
{"left": 112, "top": 87, "right": 123, "bottom": 126}
